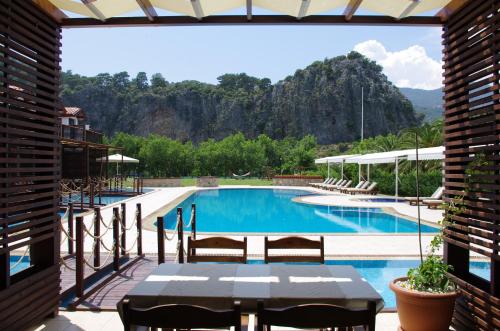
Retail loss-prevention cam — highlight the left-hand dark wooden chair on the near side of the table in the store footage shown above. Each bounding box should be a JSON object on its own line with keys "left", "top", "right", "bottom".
{"left": 123, "top": 299, "right": 241, "bottom": 331}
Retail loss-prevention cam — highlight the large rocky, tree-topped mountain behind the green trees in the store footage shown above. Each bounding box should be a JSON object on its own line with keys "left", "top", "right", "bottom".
{"left": 61, "top": 52, "right": 418, "bottom": 144}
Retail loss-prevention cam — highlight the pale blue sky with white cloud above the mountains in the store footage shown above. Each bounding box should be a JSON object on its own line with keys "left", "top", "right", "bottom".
{"left": 62, "top": 25, "right": 442, "bottom": 89}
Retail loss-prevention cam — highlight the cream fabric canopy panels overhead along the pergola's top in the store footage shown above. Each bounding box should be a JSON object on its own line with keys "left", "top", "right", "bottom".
{"left": 49, "top": 0, "right": 451, "bottom": 20}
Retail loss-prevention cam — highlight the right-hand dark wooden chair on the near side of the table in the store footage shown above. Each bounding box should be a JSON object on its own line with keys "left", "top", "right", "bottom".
{"left": 257, "top": 302, "right": 377, "bottom": 331}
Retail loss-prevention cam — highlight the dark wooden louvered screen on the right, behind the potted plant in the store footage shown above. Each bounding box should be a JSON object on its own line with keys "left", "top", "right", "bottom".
{"left": 443, "top": 0, "right": 500, "bottom": 330}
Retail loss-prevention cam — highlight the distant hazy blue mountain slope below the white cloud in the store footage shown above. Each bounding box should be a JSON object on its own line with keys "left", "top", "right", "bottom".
{"left": 399, "top": 88, "right": 443, "bottom": 122}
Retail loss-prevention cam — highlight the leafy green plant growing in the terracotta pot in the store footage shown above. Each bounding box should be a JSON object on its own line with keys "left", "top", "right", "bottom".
{"left": 401, "top": 196, "right": 465, "bottom": 293}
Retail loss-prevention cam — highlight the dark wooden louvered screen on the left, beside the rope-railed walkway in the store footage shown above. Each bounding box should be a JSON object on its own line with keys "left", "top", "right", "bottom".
{"left": 0, "top": 0, "right": 61, "bottom": 330}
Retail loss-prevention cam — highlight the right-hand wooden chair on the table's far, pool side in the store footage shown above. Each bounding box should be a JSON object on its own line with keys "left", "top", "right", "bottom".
{"left": 264, "top": 236, "right": 325, "bottom": 263}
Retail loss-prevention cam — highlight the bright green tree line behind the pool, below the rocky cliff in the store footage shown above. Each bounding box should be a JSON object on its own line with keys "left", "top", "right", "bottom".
{"left": 109, "top": 120, "right": 443, "bottom": 196}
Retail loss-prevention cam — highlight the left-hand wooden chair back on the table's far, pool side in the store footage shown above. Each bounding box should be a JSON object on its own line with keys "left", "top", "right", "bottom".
{"left": 187, "top": 237, "right": 247, "bottom": 263}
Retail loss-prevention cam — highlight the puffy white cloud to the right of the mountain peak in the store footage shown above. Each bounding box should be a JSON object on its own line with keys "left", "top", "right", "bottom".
{"left": 354, "top": 40, "right": 443, "bottom": 90}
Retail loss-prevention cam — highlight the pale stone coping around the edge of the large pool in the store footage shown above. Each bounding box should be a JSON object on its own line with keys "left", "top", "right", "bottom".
{"left": 142, "top": 186, "right": 439, "bottom": 237}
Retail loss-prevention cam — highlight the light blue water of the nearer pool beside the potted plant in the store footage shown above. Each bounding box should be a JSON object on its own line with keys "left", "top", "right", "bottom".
{"left": 248, "top": 260, "right": 489, "bottom": 309}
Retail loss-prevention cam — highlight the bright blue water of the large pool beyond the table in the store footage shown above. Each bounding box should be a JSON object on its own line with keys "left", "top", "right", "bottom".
{"left": 165, "top": 189, "right": 437, "bottom": 233}
